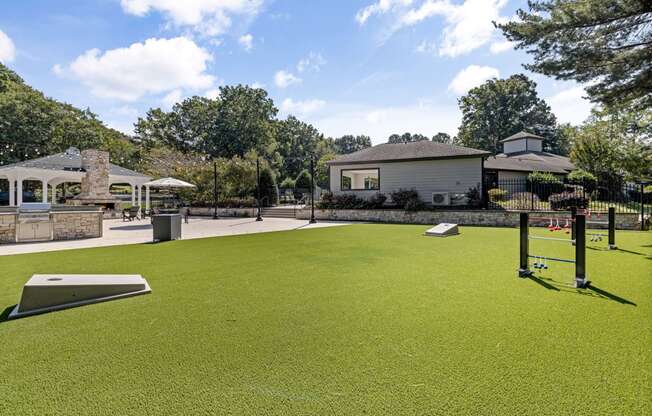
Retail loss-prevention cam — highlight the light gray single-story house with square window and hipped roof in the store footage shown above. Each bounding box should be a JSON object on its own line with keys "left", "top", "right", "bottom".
{"left": 328, "top": 141, "right": 490, "bottom": 205}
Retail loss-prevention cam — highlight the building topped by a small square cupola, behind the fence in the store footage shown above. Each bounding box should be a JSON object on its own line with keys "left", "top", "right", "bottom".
{"left": 484, "top": 131, "right": 575, "bottom": 184}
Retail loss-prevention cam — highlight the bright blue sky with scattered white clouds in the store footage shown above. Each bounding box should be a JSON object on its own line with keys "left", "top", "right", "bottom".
{"left": 0, "top": 0, "right": 591, "bottom": 143}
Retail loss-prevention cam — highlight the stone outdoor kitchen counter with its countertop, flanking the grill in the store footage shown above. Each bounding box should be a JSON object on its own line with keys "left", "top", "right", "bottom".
{"left": 0, "top": 205, "right": 103, "bottom": 244}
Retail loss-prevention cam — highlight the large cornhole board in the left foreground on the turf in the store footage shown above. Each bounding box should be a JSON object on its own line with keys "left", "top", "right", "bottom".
{"left": 9, "top": 274, "right": 152, "bottom": 319}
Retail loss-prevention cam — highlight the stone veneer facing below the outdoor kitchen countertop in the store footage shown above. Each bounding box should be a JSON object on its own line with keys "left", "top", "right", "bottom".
{"left": 0, "top": 211, "right": 103, "bottom": 244}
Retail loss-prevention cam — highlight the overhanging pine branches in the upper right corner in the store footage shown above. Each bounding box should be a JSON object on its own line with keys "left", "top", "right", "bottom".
{"left": 498, "top": 0, "right": 652, "bottom": 109}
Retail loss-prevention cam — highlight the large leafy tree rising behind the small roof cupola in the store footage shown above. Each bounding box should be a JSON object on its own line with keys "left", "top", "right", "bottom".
{"left": 457, "top": 74, "right": 558, "bottom": 153}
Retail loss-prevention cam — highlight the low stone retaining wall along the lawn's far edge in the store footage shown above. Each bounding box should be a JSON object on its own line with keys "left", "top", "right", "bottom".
{"left": 297, "top": 209, "right": 640, "bottom": 230}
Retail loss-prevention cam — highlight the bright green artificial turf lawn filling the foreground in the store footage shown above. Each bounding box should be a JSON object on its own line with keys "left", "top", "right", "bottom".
{"left": 0, "top": 224, "right": 652, "bottom": 416}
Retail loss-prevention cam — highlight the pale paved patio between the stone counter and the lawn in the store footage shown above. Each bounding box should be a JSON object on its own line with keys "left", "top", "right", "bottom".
{"left": 0, "top": 217, "right": 348, "bottom": 256}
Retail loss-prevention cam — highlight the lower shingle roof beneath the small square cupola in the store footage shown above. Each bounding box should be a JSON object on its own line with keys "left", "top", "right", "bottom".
{"left": 484, "top": 152, "right": 575, "bottom": 174}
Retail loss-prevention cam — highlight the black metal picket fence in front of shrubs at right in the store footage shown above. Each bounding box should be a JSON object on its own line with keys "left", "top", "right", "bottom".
{"left": 484, "top": 178, "right": 652, "bottom": 215}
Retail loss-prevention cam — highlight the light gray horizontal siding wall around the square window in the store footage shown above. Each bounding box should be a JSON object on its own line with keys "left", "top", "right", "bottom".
{"left": 330, "top": 158, "right": 482, "bottom": 202}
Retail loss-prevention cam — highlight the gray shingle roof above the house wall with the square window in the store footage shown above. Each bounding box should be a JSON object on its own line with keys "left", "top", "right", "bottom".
{"left": 328, "top": 140, "right": 490, "bottom": 165}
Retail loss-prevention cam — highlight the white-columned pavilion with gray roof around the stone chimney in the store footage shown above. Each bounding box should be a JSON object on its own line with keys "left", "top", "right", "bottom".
{"left": 0, "top": 148, "right": 152, "bottom": 208}
